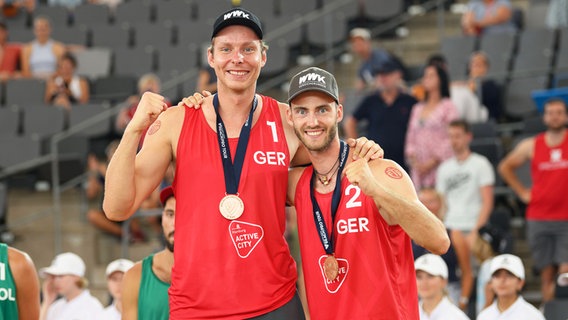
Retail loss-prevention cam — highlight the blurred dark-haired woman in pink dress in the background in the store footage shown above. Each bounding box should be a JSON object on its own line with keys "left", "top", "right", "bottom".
{"left": 404, "top": 65, "right": 458, "bottom": 190}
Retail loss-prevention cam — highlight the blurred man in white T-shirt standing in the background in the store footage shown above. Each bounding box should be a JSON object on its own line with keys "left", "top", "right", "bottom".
{"left": 436, "top": 120, "right": 495, "bottom": 248}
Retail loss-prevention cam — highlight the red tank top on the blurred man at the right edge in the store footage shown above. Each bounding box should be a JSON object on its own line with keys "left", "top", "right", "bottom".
{"left": 526, "top": 133, "right": 568, "bottom": 220}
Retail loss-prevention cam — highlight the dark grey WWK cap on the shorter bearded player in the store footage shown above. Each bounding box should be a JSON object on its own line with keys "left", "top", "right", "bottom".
{"left": 288, "top": 67, "right": 339, "bottom": 103}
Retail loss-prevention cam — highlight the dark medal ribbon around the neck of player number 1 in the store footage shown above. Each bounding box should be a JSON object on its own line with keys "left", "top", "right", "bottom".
{"left": 213, "top": 94, "right": 258, "bottom": 194}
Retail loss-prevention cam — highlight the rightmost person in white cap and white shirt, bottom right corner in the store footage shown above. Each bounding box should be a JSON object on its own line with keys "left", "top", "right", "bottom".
{"left": 477, "top": 254, "right": 544, "bottom": 320}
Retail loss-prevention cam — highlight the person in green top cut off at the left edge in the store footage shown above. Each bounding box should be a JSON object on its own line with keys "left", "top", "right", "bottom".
{"left": 0, "top": 243, "right": 39, "bottom": 320}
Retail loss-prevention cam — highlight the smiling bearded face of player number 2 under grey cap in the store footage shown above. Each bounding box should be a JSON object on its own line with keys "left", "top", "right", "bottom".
{"left": 288, "top": 91, "right": 343, "bottom": 151}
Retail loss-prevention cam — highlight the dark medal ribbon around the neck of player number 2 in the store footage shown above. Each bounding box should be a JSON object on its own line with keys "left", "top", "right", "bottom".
{"left": 310, "top": 140, "right": 349, "bottom": 255}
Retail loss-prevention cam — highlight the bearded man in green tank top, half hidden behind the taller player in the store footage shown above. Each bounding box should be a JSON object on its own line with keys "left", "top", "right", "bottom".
{"left": 122, "top": 186, "right": 176, "bottom": 320}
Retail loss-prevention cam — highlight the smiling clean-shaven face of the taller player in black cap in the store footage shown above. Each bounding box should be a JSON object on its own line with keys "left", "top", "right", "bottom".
{"left": 207, "top": 25, "right": 266, "bottom": 91}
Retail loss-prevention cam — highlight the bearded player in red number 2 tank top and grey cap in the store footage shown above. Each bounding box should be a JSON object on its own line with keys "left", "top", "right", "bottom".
{"left": 287, "top": 68, "right": 450, "bottom": 319}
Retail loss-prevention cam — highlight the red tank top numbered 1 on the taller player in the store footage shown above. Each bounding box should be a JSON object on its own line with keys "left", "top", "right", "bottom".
{"left": 169, "top": 97, "right": 297, "bottom": 319}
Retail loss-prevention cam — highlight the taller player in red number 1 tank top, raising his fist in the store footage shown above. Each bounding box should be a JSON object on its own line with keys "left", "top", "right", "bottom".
{"left": 103, "top": 8, "right": 381, "bottom": 320}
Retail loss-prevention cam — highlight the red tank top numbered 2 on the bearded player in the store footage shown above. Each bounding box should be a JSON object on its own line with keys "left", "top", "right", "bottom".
{"left": 295, "top": 167, "right": 419, "bottom": 320}
